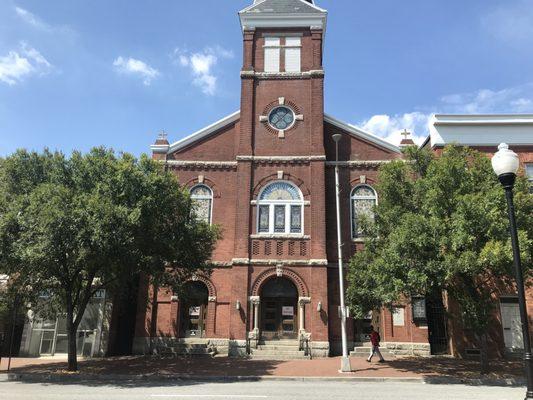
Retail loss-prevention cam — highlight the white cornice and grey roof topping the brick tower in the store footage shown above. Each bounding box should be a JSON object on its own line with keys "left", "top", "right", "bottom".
{"left": 239, "top": 0, "right": 327, "bottom": 31}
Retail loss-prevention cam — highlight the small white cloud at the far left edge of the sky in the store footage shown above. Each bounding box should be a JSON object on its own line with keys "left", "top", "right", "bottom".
{"left": 0, "top": 42, "right": 52, "bottom": 85}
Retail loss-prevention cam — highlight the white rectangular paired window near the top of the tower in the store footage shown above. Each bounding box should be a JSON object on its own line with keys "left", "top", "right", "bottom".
{"left": 264, "top": 36, "right": 302, "bottom": 72}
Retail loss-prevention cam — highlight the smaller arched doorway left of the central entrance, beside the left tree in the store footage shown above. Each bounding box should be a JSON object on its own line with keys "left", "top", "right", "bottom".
{"left": 180, "top": 281, "right": 209, "bottom": 337}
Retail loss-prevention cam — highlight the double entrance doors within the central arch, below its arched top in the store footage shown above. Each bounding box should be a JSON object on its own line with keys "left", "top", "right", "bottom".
{"left": 261, "top": 297, "right": 298, "bottom": 340}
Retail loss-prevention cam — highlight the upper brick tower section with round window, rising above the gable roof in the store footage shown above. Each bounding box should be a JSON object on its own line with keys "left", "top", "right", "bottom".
{"left": 239, "top": 0, "right": 327, "bottom": 156}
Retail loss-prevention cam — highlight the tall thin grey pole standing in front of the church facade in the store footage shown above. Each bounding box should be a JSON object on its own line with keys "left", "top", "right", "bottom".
{"left": 332, "top": 133, "right": 352, "bottom": 372}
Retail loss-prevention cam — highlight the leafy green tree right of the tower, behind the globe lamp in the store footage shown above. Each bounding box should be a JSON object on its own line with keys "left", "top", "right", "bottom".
{"left": 347, "top": 146, "right": 533, "bottom": 368}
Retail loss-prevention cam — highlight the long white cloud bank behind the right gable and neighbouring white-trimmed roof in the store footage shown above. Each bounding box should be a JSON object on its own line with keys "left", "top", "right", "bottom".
{"left": 358, "top": 83, "right": 533, "bottom": 145}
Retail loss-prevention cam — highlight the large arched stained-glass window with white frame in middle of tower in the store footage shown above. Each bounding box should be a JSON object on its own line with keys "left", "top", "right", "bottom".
{"left": 257, "top": 181, "right": 304, "bottom": 235}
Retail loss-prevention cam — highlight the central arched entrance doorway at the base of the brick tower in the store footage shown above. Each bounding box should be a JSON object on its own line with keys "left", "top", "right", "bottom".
{"left": 261, "top": 278, "right": 298, "bottom": 340}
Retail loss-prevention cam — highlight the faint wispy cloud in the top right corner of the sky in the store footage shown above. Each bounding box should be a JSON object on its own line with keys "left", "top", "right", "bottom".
{"left": 481, "top": 0, "right": 533, "bottom": 46}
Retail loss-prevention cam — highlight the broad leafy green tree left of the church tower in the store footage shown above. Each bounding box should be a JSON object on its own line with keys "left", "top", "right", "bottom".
{"left": 0, "top": 148, "right": 219, "bottom": 371}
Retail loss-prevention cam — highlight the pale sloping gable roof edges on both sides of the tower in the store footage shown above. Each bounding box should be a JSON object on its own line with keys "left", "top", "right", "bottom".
{"left": 150, "top": 110, "right": 401, "bottom": 154}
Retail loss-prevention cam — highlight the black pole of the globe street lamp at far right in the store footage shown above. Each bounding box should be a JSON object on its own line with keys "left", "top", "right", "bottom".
{"left": 504, "top": 185, "right": 533, "bottom": 399}
